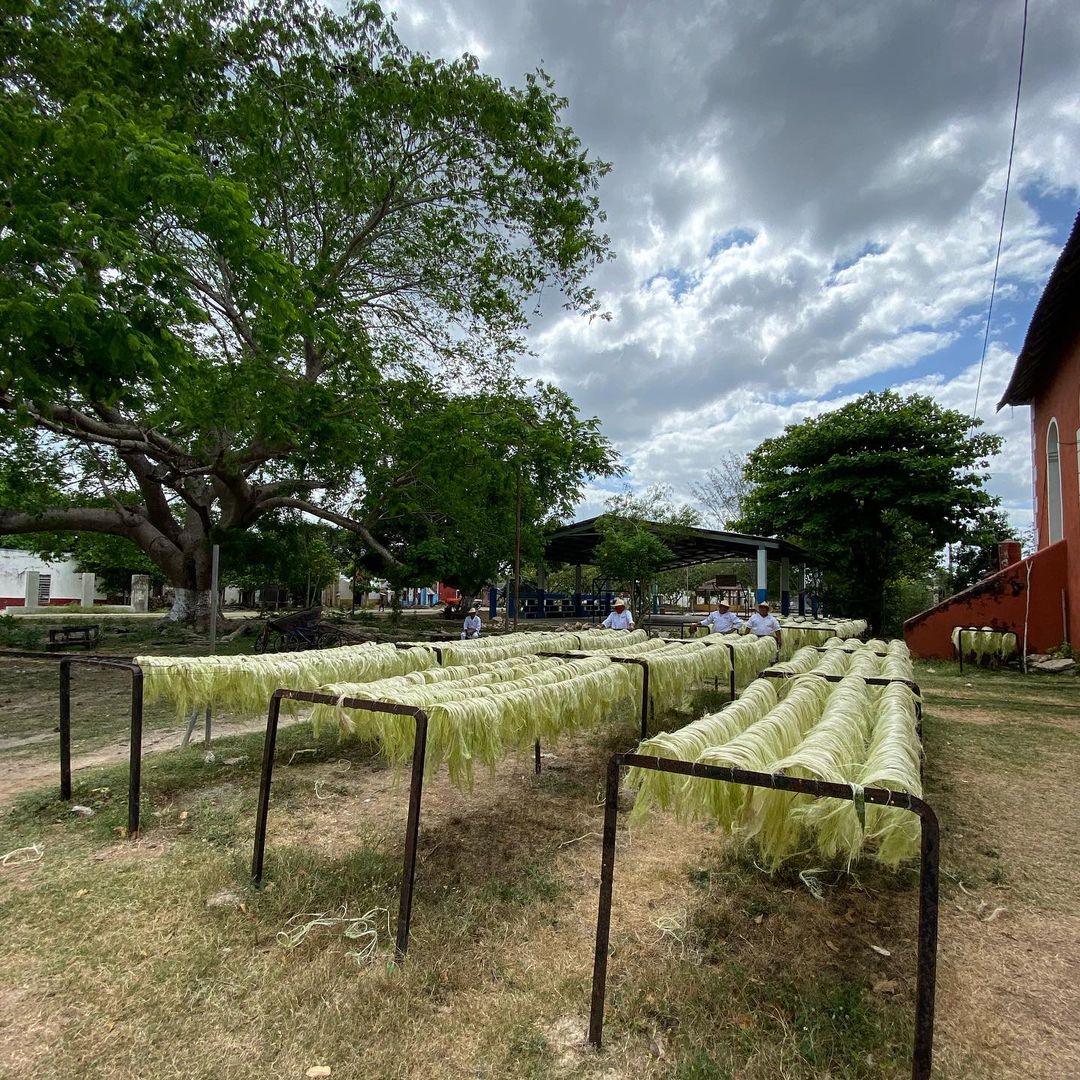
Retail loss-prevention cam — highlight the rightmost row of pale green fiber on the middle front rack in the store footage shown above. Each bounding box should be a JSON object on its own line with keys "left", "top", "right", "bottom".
{"left": 312, "top": 657, "right": 634, "bottom": 787}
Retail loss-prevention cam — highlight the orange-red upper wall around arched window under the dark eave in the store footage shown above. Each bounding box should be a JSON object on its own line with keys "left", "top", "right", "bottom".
{"left": 1031, "top": 338, "right": 1080, "bottom": 647}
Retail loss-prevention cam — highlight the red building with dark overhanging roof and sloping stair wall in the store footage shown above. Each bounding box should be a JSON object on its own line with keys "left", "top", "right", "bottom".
{"left": 904, "top": 215, "right": 1080, "bottom": 657}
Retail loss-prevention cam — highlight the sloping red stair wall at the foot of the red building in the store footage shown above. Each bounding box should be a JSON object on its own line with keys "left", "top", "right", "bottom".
{"left": 904, "top": 540, "right": 1080, "bottom": 660}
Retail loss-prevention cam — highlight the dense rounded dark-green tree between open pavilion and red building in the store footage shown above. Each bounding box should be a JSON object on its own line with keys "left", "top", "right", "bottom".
{"left": 739, "top": 392, "right": 1001, "bottom": 631}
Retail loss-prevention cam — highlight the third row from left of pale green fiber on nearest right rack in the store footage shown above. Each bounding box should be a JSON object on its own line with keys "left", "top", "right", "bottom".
{"left": 743, "top": 675, "right": 873, "bottom": 867}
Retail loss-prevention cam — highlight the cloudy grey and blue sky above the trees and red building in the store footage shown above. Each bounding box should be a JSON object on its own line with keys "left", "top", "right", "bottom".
{"left": 390, "top": 0, "right": 1080, "bottom": 528}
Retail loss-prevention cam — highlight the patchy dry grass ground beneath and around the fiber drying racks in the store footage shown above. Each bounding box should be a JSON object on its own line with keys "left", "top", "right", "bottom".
{"left": 0, "top": 661, "right": 1080, "bottom": 1080}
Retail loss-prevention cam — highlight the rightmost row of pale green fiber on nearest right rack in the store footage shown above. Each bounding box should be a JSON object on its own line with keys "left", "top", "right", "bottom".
{"left": 798, "top": 683, "right": 922, "bottom": 868}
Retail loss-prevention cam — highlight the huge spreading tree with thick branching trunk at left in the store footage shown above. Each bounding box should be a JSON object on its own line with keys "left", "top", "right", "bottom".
{"left": 0, "top": 0, "right": 609, "bottom": 616}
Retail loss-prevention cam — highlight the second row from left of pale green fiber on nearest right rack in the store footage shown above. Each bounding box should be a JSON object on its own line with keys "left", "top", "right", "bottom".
{"left": 674, "top": 675, "right": 832, "bottom": 828}
